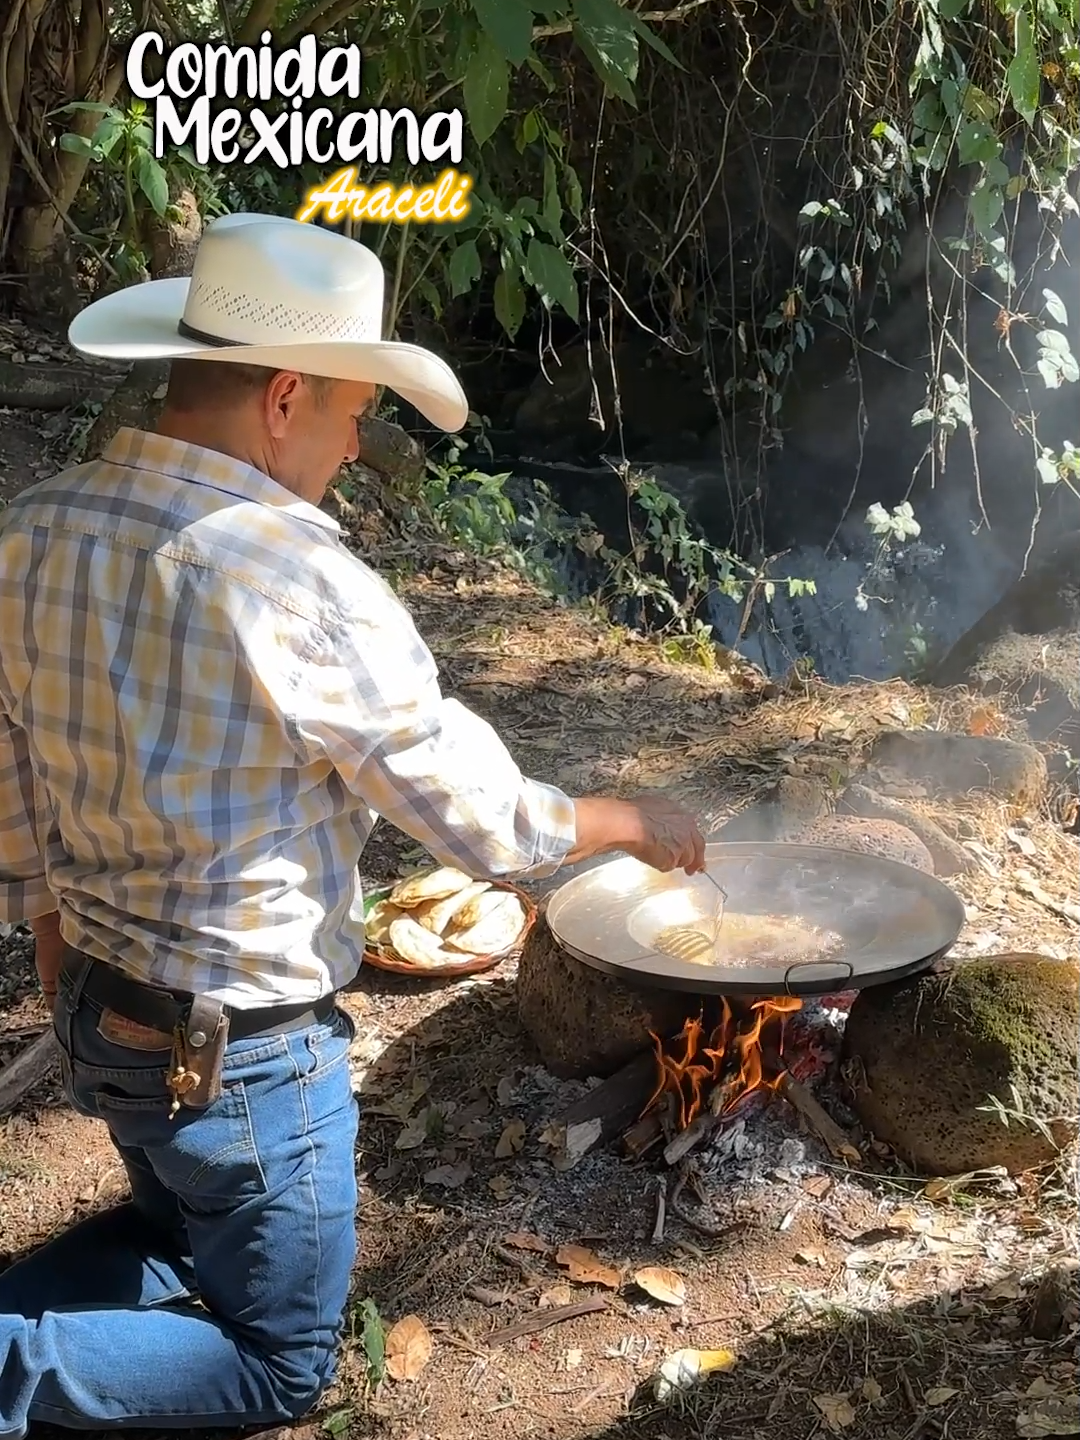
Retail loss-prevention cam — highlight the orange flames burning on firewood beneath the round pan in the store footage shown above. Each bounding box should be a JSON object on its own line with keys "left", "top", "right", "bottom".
{"left": 642, "top": 995, "right": 802, "bottom": 1130}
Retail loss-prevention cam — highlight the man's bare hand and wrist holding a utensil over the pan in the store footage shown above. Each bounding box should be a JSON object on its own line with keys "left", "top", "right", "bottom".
{"left": 566, "top": 795, "right": 706, "bottom": 876}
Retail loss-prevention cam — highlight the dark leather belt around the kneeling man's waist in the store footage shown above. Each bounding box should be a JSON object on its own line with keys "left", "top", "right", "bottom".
{"left": 63, "top": 950, "right": 337, "bottom": 1040}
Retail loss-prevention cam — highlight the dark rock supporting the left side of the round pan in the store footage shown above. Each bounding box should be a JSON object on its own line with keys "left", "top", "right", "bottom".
{"left": 517, "top": 914, "right": 698, "bottom": 1080}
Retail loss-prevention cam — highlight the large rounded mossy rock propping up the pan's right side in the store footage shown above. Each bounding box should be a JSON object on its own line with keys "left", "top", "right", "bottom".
{"left": 844, "top": 955, "right": 1080, "bottom": 1175}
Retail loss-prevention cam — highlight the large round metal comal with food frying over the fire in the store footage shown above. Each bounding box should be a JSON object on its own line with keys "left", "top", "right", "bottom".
{"left": 547, "top": 842, "right": 965, "bottom": 995}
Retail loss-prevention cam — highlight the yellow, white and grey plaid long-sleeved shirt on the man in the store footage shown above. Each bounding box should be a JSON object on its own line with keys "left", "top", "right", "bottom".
{"left": 0, "top": 429, "right": 575, "bottom": 1008}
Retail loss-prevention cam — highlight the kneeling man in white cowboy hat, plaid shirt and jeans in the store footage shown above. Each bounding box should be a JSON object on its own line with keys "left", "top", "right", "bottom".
{"left": 0, "top": 216, "right": 703, "bottom": 1437}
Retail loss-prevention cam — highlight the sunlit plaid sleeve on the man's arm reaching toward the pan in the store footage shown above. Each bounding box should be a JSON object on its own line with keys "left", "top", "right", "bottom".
{"left": 297, "top": 576, "right": 576, "bottom": 878}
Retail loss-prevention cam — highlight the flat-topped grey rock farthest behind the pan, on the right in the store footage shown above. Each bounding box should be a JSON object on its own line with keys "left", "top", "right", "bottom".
{"left": 868, "top": 730, "right": 1047, "bottom": 809}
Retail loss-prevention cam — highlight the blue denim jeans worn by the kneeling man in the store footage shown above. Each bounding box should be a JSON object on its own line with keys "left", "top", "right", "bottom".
{"left": 0, "top": 972, "right": 364, "bottom": 1437}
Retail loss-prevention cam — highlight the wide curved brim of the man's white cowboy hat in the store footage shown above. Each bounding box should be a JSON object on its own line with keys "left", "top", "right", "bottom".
{"left": 68, "top": 279, "right": 469, "bottom": 433}
